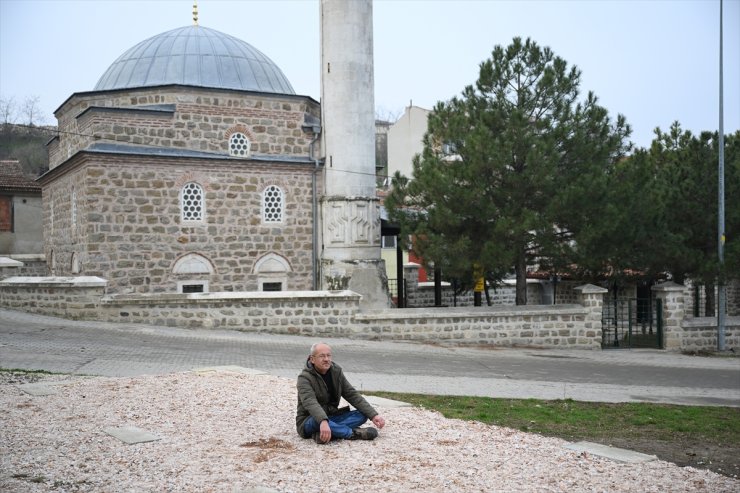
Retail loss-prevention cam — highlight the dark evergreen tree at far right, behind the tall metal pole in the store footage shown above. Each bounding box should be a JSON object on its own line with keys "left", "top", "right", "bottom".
{"left": 644, "top": 122, "right": 740, "bottom": 306}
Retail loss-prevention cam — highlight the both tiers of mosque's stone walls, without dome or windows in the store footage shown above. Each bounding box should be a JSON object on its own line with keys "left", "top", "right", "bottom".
{"left": 41, "top": 86, "right": 321, "bottom": 294}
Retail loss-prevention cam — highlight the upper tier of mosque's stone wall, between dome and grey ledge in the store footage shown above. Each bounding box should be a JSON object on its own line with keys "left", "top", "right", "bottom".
{"left": 49, "top": 86, "right": 320, "bottom": 169}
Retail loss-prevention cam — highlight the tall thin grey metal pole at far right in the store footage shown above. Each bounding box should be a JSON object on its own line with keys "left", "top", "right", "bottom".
{"left": 717, "top": 0, "right": 727, "bottom": 351}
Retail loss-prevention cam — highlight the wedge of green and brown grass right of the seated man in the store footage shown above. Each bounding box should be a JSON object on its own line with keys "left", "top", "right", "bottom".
{"left": 367, "top": 392, "right": 740, "bottom": 478}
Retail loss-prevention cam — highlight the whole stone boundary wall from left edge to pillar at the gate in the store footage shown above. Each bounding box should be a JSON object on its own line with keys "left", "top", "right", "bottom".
{"left": 0, "top": 277, "right": 606, "bottom": 349}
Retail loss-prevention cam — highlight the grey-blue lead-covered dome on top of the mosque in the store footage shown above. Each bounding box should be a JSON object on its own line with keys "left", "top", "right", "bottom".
{"left": 95, "top": 25, "right": 295, "bottom": 94}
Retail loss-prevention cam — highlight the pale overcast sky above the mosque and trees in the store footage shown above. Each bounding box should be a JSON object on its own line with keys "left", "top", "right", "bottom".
{"left": 0, "top": 0, "right": 740, "bottom": 146}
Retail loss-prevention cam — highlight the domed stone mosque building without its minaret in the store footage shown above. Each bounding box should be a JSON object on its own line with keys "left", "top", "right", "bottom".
{"left": 39, "top": 24, "right": 322, "bottom": 294}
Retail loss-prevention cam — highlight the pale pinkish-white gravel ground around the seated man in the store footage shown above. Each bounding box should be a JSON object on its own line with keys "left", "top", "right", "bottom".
{"left": 0, "top": 372, "right": 740, "bottom": 493}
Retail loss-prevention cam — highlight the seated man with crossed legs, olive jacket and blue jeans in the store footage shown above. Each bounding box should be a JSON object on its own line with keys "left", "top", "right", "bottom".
{"left": 296, "top": 343, "right": 385, "bottom": 443}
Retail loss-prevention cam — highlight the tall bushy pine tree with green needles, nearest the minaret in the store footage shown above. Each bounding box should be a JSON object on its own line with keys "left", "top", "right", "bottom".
{"left": 386, "top": 38, "right": 630, "bottom": 304}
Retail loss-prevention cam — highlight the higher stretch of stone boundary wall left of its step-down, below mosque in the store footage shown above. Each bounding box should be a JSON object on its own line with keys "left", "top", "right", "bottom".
{"left": 0, "top": 277, "right": 361, "bottom": 337}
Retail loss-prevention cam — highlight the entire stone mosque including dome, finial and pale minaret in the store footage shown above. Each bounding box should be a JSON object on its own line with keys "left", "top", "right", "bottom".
{"left": 39, "top": 0, "right": 388, "bottom": 306}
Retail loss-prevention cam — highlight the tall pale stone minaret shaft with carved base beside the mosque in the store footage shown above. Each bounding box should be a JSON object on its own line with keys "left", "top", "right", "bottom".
{"left": 321, "top": 0, "right": 389, "bottom": 308}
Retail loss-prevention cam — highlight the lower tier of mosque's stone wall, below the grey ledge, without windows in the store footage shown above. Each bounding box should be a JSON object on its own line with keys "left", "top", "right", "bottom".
{"left": 44, "top": 155, "right": 313, "bottom": 293}
